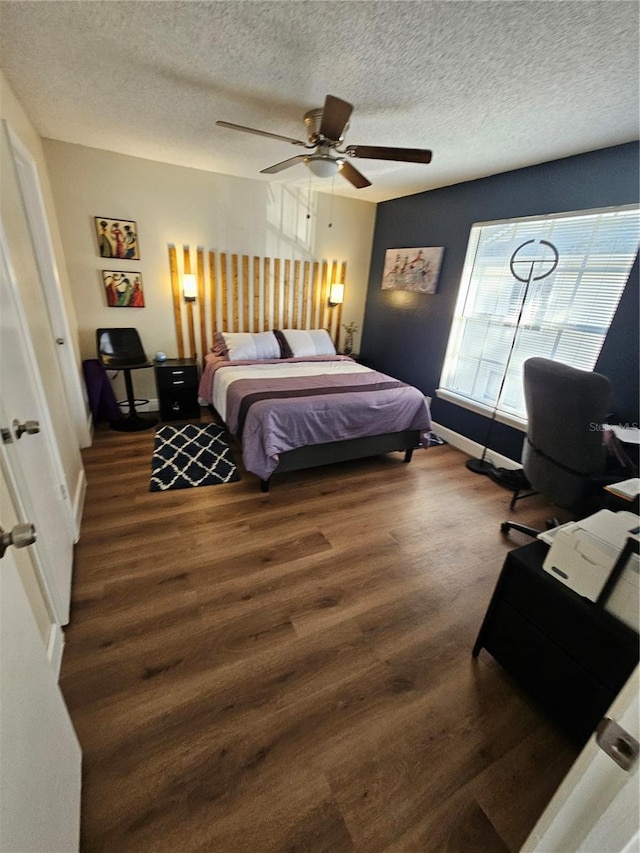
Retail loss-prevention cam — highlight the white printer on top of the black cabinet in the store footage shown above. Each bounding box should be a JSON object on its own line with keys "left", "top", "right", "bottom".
{"left": 539, "top": 509, "right": 640, "bottom": 631}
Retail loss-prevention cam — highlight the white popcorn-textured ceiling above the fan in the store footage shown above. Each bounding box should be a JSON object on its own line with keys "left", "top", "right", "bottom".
{"left": 0, "top": 0, "right": 639, "bottom": 201}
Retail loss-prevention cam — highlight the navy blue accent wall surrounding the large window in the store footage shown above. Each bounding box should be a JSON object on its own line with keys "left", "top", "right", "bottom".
{"left": 360, "top": 143, "right": 640, "bottom": 459}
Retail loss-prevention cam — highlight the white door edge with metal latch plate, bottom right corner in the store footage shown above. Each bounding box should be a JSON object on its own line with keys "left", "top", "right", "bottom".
{"left": 521, "top": 667, "right": 640, "bottom": 853}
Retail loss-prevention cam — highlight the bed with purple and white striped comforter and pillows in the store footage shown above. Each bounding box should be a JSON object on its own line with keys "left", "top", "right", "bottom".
{"left": 198, "top": 330, "right": 431, "bottom": 491}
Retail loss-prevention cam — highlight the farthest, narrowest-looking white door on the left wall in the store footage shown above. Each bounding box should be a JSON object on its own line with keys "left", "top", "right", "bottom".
{"left": 5, "top": 122, "right": 91, "bottom": 447}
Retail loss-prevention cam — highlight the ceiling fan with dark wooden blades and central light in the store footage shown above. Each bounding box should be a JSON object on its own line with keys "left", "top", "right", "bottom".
{"left": 216, "top": 95, "right": 431, "bottom": 189}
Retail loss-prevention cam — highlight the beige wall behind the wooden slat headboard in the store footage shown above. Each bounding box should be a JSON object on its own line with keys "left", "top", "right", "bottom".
{"left": 43, "top": 140, "right": 376, "bottom": 399}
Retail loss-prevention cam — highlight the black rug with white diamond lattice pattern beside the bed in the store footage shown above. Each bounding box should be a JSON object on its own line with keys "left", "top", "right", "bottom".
{"left": 149, "top": 424, "right": 240, "bottom": 492}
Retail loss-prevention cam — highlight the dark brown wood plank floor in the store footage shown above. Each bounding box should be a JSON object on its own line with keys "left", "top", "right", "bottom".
{"left": 61, "top": 416, "right": 577, "bottom": 853}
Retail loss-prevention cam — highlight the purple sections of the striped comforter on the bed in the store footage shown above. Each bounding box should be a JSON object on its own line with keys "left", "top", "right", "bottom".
{"left": 201, "top": 356, "right": 431, "bottom": 480}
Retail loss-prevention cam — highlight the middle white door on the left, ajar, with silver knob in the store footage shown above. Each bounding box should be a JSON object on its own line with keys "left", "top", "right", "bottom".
{"left": 0, "top": 227, "right": 75, "bottom": 625}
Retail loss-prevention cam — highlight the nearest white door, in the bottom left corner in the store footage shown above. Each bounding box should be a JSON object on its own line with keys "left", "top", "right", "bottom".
{"left": 0, "top": 490, "right": 81, "bottom": 853}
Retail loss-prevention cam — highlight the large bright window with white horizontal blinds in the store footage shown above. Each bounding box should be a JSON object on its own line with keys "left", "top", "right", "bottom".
{"left": 437, "top": 207, "right": 640, "bottom": 425}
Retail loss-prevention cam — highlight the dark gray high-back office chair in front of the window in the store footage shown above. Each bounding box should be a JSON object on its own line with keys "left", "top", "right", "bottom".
{"left": 501, "top": 358, "right": 611, "bottom": 536}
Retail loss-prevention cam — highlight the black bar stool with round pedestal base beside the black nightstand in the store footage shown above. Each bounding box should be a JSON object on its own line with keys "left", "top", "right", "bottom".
{"left": 96, "top": 328, "right": 158, "bottom": 432}
